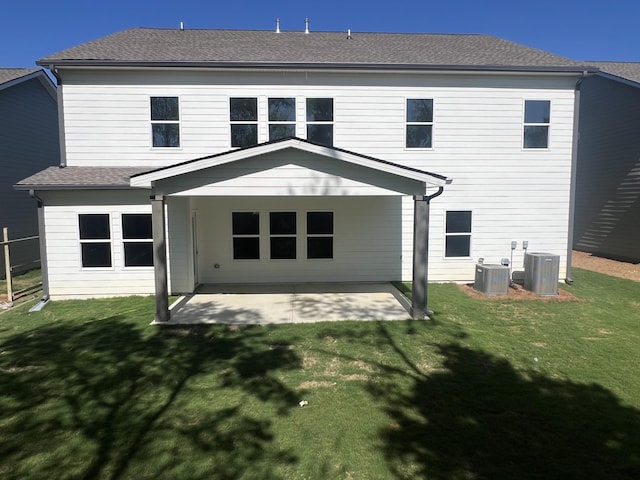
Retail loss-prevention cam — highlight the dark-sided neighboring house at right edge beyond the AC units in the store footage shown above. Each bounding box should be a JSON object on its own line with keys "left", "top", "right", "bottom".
{"left": 573, "top": 62, "right": 640, "bottom": 262}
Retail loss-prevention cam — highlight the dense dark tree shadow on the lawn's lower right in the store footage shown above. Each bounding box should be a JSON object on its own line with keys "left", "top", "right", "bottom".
{"left": 368, "top": 338, "right": 640, "bottom": 480}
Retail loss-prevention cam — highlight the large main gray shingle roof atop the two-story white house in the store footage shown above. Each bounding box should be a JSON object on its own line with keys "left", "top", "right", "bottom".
{"left": 37, "top": 28, "right": 583, "bottom": 71}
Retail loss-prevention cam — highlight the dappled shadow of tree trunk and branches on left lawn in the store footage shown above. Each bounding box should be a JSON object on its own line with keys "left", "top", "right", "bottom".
{"left": 0, "top": 316, "right": 300, "bottom": 479}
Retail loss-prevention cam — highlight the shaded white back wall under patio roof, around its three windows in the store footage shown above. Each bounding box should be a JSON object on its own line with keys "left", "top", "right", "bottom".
{"left": 192, "top": 197, "right": 402, "bottom": 283}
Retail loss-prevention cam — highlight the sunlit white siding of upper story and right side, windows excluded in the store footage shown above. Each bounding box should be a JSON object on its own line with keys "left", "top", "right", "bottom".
{"left": 53, "top": 70, "right": 577, "bottom": 285}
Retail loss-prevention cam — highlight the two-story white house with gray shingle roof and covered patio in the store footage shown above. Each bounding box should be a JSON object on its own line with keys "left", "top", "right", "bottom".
{"left": 18, "top": 29, "right": 595, "bottom": 320}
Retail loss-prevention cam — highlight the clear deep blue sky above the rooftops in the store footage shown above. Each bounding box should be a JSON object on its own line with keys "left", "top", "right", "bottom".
{"left": 0, "top": 0, "right": 640, "bottom": 67}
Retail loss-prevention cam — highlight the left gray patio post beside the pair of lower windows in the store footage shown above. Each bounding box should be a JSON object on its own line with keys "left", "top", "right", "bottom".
{"left": 151, "top": 195, "right": 170, "bottom": 322}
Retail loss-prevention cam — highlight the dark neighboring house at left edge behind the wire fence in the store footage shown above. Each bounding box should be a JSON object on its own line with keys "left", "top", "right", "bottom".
{"left": 0, "top": 68, "right": 60, "bottom": 278}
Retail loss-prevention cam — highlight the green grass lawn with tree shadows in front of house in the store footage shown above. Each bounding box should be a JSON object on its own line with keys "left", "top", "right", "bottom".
{"left": 0, "top": 269, "right": 640, "bottom": 480}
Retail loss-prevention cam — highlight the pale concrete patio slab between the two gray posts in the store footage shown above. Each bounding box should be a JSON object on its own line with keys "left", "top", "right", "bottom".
{"left": 169, "top": 283, "right": 410, "bottom": 325}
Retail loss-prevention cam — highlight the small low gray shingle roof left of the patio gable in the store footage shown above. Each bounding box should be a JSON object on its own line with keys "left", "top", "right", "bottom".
{"left": 15, "top": 167, "right": 149, "bottom": 190}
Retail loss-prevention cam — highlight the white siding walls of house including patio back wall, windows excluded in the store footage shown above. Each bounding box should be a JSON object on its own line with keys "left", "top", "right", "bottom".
{"left": 37, "top": 70, "right": 576, "bottom": 296}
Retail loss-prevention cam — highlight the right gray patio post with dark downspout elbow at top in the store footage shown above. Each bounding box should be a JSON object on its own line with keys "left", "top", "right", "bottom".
{"left": 410, "top": 187, "right": 444, "bottom": 320}
